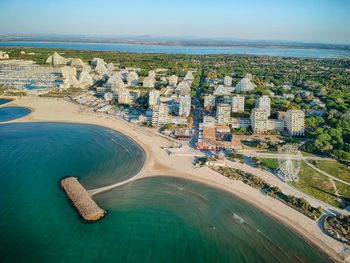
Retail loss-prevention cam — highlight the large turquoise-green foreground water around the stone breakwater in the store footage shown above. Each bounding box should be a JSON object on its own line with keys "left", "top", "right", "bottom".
{"left": 0, "top": 123, "right": 328, "bottom": 262}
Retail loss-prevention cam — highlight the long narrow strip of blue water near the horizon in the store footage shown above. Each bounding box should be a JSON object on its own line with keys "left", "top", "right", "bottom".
{"left": 0, "top": 41, "right": 350, "bottom": 58}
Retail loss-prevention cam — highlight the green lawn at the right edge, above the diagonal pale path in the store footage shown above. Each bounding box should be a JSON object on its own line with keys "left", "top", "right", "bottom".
{"left": 313, "top": 161, "right": 350, "bottom": 184}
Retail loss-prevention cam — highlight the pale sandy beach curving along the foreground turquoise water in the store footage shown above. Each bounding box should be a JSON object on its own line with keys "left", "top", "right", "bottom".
{"left": 6, "top": 96, "right": 350, "bottom": 262}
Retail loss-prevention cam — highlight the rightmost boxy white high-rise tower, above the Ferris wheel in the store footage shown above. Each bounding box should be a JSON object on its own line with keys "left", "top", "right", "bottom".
{"left": 285, "top": 110, "right": 305, "bottom": 136}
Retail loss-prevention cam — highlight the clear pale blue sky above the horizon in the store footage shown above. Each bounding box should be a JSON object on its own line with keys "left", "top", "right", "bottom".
{"left": 0, "top": 0, "right": 350, "bottom": 44}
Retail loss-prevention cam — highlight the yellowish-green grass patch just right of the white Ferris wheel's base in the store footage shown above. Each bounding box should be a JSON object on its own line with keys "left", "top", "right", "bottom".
{"left": 292, "top": 163, "right": 340, "bottom": 207}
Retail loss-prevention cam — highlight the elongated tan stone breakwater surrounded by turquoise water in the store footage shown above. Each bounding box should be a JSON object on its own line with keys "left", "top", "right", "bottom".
{"left": 61, "top": 177, "right": 106, "bottom": 221}
